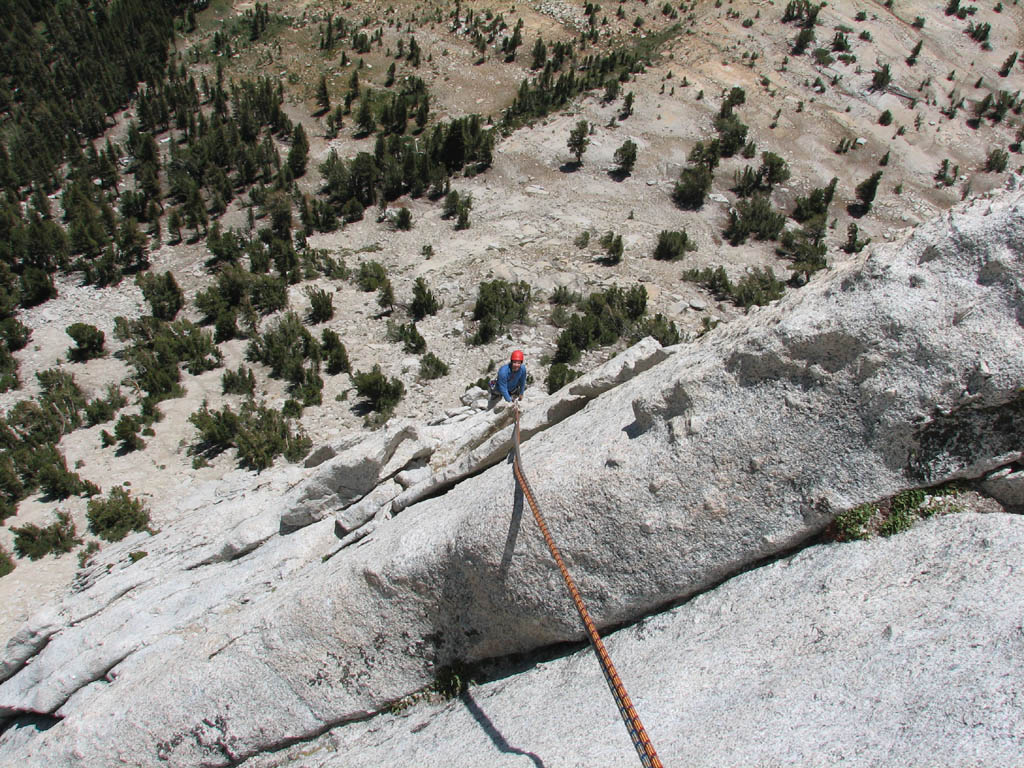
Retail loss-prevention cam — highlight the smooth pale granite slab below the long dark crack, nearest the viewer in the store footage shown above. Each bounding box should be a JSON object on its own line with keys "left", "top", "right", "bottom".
{"left": 247, "top": 514, "right": 1024, "bottom": 768}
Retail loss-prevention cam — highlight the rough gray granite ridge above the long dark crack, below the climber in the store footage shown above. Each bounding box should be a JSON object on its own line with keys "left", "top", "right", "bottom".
{"left": 0, "top": 188, "right": 1024, "bottom": 766}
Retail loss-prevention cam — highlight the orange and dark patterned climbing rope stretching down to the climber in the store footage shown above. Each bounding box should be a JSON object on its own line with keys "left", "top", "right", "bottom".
{"left": 512, "top": 403, "right": 662, "bottom": 768}
